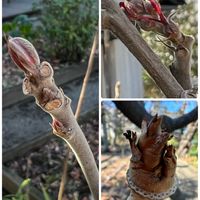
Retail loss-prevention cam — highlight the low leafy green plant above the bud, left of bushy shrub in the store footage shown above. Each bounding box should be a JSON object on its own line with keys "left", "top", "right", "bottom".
{"left": 3, "top": 15, "right": 36, "bottom": 40}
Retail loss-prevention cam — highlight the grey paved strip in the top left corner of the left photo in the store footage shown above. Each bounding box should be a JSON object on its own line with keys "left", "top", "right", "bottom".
{"left": 2, "top": 0, "right": 39, "bottom": 19}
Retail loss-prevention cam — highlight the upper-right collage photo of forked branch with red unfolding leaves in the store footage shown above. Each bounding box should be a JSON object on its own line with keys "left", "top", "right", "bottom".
{"left": 101, "top": 0, "right": 198, "bottom": 98}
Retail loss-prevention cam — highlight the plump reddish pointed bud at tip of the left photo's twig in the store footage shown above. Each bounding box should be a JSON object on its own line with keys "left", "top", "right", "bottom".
{"left": 8, "top": 37, "right": 40, "bottom": 75}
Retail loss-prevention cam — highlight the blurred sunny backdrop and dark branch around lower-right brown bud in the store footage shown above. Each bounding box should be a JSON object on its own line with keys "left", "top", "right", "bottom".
{"left": 101, "top": 101, "right": 198, "bottom": 200}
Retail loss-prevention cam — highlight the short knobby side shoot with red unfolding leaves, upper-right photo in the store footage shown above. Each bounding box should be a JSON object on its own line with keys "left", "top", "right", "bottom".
{"left": 120, "top": 0, "right": 194, "bottom": 90}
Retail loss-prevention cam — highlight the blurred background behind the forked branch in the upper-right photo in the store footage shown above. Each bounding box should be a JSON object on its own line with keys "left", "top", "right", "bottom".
{"left": 101, "top": 0, "right": 198, "bottom": 98}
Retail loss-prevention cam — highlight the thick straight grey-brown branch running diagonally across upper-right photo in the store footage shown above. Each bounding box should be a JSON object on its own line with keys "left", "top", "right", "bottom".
{"left": 102, "top": 0, "right": 195, "bottom": 98}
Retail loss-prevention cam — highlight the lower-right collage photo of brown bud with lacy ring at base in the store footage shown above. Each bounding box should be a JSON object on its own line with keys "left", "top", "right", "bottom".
{"left": 101, "top": 100, "right": 198, "bottom": 200}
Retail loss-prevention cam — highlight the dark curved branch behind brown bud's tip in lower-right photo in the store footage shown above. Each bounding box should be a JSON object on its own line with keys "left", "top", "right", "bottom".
{"left": 114, "top": 101, "right": 198, "bottom": 132}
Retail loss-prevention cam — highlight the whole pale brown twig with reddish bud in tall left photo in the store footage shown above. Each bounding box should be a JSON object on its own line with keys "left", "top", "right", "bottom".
{"left": 8, "top": 38, "right": 99, "bottom": 200}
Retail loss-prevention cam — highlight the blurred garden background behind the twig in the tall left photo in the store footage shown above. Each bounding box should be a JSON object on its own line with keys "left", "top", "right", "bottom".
{"left": 2, "top": 0, "right": 99, "bottom": 200}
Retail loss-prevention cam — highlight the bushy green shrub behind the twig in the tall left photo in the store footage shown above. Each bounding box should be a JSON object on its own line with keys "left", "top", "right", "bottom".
{"left": 38, "top": 0, "right": 98, "bottom": 61}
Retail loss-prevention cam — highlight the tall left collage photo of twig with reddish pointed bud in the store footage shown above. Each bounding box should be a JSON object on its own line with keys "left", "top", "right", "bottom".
{"left": 0, "top": 0, "right": 99, "bottom": 200}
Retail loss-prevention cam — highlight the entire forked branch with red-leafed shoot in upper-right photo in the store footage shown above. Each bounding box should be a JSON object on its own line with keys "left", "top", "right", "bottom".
{"left": 102, "top": 0, "right": 196, "bottom": 98}
